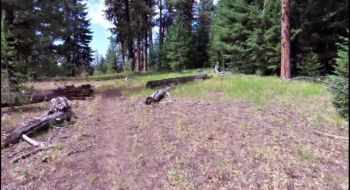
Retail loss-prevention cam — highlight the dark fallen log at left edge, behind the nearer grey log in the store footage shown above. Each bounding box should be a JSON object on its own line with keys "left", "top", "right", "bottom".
{"left": 1, "top": 84, "right": 94, "bottom": 107}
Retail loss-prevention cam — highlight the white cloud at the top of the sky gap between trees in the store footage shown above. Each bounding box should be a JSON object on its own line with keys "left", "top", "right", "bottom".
{"left": 87, "top": 0, "right": 113, "bottom": 35}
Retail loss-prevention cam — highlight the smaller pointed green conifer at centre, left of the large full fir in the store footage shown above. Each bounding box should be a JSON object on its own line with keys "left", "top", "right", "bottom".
{"left": 164, "top": 16, "right": 191, "bottom": 72}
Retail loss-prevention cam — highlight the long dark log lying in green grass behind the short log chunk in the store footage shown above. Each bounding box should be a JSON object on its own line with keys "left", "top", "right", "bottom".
{"left": 146, "top": 74, "right": 213, "bottom": 88}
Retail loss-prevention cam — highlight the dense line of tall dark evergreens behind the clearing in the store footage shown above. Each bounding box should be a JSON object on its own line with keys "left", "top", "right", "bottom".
{"left": 1, "top": 0, "right": 349, "bottom": 119}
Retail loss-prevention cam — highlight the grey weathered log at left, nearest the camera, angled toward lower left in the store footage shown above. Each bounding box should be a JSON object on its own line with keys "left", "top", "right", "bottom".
{"left": 2, "top": 112, "right": 72, "bottom": 147}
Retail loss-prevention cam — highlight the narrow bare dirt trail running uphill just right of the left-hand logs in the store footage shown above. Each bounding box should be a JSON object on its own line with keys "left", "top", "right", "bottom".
{"left": 87, "top": 89, "right": 142, "bottom": 189}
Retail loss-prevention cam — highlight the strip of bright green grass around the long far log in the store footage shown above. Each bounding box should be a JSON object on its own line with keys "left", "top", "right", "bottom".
{"left": 123, "top": 70, "right": 329, "bottom": 104}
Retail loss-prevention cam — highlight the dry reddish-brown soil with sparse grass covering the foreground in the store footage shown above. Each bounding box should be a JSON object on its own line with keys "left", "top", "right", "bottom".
{"left": 1, "top": 89, "right": 349, "bottom": 190}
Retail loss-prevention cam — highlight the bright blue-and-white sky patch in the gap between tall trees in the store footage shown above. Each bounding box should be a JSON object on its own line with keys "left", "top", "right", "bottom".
{"left": 87, "top": 0, "right": 218, "bottom": 55}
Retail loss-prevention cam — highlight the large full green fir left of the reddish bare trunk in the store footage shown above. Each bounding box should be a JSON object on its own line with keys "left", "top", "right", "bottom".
{"left": 211, "top": 0, "right": 259, "bottom": 74}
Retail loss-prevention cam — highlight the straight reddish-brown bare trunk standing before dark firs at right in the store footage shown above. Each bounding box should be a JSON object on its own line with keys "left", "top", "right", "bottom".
{"left": 281, "top": 0, "right": 291, "bottom": 80}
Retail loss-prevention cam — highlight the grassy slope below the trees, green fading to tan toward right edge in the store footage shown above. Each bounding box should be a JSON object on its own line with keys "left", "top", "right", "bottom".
{"left": 115, "top": 70, "right": 345, "bottom": 126}
